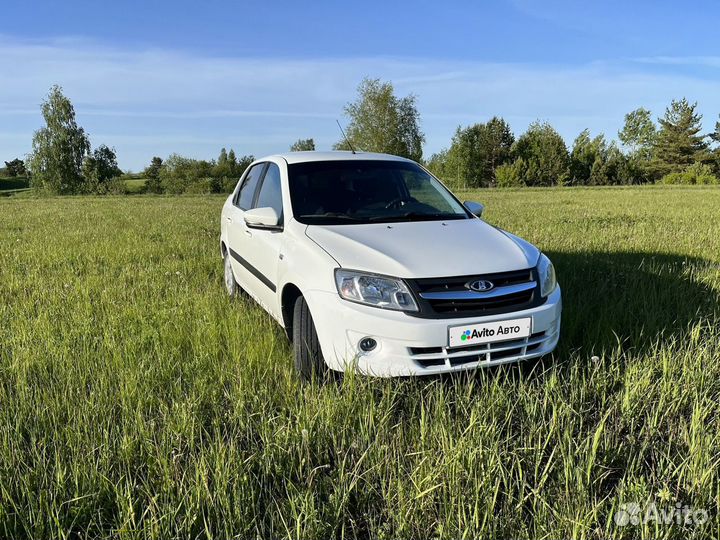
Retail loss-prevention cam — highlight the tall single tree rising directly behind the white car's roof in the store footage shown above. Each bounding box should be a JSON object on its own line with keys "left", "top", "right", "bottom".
{"left": 335, "top": 79, "right": 425, "bottom": 161}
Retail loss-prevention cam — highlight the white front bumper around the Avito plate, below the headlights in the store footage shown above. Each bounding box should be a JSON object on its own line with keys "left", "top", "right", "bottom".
{"left": 305, "top": 286, "right": 562, "bottom": 377}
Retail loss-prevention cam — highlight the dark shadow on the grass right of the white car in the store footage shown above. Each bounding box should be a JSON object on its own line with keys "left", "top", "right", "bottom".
{"left": 548, "top": 252, "right": 720, "bottom": 357}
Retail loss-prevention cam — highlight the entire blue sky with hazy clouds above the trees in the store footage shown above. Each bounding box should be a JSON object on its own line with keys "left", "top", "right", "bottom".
{"left": 0, "top": 0, "right": 720, "bottom": 170}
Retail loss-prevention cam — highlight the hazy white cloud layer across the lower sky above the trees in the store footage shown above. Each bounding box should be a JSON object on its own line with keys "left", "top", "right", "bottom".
{"left": 0, "top": 38, "right": 720, "bottom": 169}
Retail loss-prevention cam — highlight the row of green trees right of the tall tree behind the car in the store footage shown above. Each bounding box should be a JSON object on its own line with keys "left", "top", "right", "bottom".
{"left": 427, "top": 99, "right": 720, "bottom": 187}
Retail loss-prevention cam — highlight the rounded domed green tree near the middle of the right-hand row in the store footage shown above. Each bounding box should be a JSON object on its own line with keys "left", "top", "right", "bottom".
{"left": 512, "top": 122, "right": 570, "bottom": 186}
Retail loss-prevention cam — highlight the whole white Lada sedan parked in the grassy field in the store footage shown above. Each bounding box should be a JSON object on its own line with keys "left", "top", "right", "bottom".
{"left": 220, "top": 152, "right": 562, "bottom": 379}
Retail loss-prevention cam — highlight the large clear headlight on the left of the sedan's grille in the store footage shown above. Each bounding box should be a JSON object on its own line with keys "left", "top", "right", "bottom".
{"left": 335, "top": 268, "right": 418, "bottom": 311}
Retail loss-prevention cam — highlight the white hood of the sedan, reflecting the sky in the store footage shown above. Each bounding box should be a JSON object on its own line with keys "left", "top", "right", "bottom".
{"left": 305, "top": 219, "right": 539, "bottom": 278}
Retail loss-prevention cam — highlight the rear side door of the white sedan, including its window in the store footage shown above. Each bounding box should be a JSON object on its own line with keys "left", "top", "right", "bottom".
{"left": 225, "top": 163, "right": 267, "bottom": 297}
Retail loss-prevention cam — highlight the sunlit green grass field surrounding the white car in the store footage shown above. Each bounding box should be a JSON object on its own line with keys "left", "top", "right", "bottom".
{"left": 0, "top": 187, "right": 720, "bottom": 540}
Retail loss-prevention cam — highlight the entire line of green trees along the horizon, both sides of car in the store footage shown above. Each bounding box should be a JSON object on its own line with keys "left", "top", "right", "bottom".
{"left": 7, "top": 79, "right": 720, "bottom": 193}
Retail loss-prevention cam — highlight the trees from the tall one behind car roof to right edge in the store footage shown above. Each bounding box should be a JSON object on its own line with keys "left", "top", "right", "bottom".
{"left": 335, "top": 79, "right": 720, "bottom": 188}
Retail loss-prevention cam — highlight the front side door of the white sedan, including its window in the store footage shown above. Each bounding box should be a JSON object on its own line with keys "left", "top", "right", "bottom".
{"left": 235, "top": 162, "right": 283, "bottom": 319}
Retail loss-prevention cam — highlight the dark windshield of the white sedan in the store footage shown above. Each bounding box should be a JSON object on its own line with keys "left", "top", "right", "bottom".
{"left": 288, "top": 160, "right": 470, "bottom": 225}
